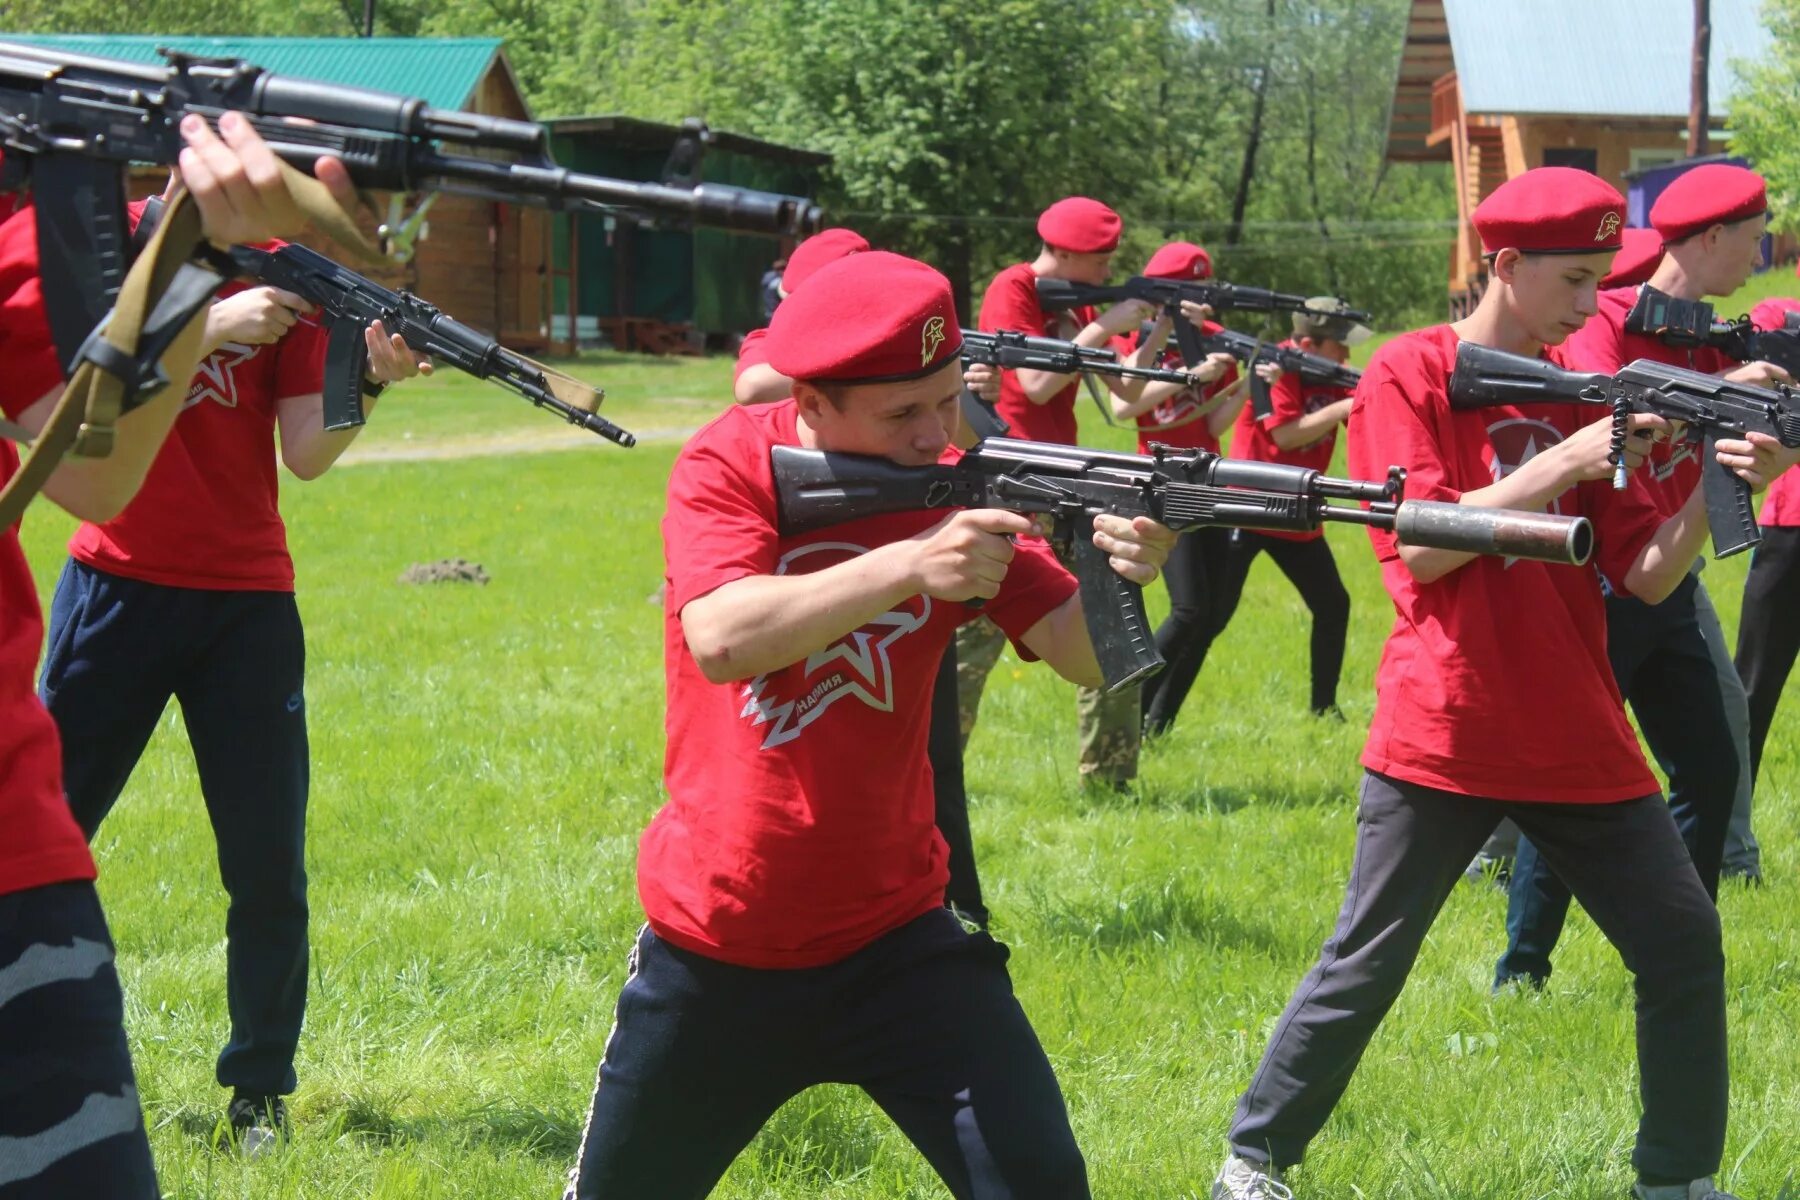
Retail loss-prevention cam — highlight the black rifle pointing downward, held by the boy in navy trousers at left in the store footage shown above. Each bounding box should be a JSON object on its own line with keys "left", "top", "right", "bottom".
{"left": 230, "top": 245, "right": 637, "bottom": 446}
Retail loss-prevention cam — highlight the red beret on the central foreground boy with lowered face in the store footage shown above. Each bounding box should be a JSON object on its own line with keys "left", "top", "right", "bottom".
{"left": 765, "top": 250, "right": 963, "bottom": 383}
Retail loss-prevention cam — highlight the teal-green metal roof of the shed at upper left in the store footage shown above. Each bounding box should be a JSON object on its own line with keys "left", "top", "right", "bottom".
{"left": 5, "top": 34, "right": 502, "bottom": 110}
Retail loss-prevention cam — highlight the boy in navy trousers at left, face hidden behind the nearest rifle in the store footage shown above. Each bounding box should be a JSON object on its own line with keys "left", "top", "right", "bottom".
{"left": 38, "top": 173, "right": 428, "bottom": 1151}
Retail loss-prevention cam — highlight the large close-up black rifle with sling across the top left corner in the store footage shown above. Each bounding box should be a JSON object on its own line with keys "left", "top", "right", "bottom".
{"left": 0, "top": 41, "right": 819, "bottom": 376}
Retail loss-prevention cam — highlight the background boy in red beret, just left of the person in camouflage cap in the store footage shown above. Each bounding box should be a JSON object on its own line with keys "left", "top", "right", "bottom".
{"left": 1112, "top": 241, "right": 1246, "bottom": 734}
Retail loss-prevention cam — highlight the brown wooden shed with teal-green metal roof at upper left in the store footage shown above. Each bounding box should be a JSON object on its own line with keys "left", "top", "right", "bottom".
{"left": 14, "top": 34, "right": 549, "bottom": 349}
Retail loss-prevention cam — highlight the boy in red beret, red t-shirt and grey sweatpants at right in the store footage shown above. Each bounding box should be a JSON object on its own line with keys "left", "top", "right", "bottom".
{"left": 1213, "top": 167, "right": 1787, "bottom": 1200}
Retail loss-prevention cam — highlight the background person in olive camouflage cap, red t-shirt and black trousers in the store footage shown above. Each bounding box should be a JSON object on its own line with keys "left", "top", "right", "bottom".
{"left": 1168, "top": 299, "right": 1368, "bottom": 734}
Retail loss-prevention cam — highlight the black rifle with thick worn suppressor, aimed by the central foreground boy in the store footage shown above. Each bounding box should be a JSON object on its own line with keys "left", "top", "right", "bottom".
{"left": 772, "top": 437, "right": 1593, "bottom": 691}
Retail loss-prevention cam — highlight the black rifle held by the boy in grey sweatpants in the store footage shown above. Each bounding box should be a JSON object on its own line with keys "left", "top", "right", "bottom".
{"left": 1449, "top": 342, "right": 1800, "bottom": 558}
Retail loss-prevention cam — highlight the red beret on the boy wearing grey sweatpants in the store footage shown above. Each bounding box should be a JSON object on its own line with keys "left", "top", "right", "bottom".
{"left": 1472, "top": 167, "right": 1625, "bottom": 254}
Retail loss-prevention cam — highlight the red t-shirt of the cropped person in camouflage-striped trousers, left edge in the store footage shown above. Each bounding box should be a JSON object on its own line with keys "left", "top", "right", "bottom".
{"left": 0, "top": 207, "right": 94, "bottom": 894}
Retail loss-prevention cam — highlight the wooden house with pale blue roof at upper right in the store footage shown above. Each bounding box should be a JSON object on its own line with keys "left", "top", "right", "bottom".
{"left": 1388, "top": 0, "right": 1769, "bottom": 315}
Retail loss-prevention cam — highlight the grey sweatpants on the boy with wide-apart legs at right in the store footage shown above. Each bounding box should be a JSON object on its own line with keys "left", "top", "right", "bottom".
{"left": 1229, "top": 772, "right": 1728, "bottom": 1178}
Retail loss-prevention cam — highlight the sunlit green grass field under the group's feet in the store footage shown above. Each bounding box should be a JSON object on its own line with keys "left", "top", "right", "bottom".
{"left": 25, "top": 298, "right": 1800, "bottom": 1200}
